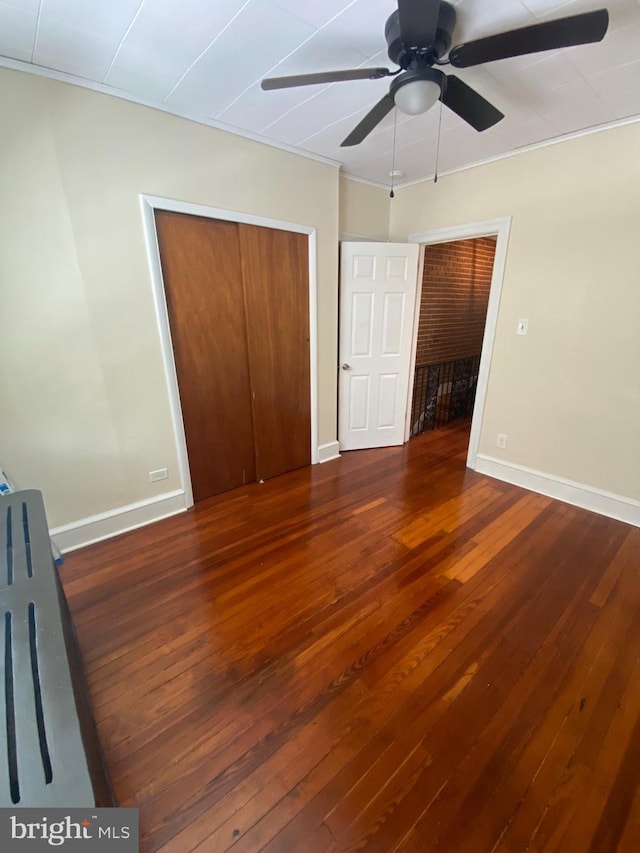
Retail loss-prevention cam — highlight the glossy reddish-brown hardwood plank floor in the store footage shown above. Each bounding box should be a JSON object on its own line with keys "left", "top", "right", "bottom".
{"left": 62, "top": 424, "right": 640, "bottom": 853}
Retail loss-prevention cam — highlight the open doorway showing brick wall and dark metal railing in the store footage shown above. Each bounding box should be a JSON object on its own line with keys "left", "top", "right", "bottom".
{"left": 410, "top": 235, "right": 497, "bottom": 437}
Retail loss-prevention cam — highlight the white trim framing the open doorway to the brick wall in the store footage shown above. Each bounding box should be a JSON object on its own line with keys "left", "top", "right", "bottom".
{"left": 409, "top": 216, "right": 511, "bottom": 469}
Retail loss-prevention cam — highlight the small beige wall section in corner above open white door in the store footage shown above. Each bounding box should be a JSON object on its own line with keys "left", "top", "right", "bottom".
{"left": 340, "top": 175, "right": 390, "bottom": 242}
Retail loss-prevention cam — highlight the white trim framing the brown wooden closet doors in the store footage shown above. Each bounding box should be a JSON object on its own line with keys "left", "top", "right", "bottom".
{"left": 140, "top": 194, "right": 318, "bottom": 507}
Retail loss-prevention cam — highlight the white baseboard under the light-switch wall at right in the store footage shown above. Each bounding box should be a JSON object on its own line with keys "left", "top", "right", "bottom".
{"left": 475, "top": 453, "right": 640, "bottom": 527}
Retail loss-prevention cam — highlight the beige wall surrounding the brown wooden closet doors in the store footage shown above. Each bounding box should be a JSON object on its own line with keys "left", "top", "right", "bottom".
{"left": 0, "top": 70, "right": 338, "bottom": 526}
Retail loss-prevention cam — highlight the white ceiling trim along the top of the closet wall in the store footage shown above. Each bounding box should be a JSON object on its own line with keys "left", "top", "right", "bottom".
{"left": 0, "top": 56, "right": 342, "bottom": 169}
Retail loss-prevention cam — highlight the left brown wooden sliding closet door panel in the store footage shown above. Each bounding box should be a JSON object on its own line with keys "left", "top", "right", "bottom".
{"left": 155, "top": 211, "right": 256, "bottom": 501}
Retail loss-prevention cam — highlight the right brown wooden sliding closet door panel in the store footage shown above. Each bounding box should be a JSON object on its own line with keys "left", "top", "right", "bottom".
{"left": 239, "top": 224, "right": 311, "bottom": 480}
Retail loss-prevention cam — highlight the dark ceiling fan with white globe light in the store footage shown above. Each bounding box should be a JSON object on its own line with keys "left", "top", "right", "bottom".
{"left": 261, "top": 0, "right": 609, "bottom": 146}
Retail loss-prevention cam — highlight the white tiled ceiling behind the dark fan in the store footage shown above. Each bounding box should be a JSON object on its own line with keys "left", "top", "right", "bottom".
{"left": 0, "top": 0, "right": 640, "bottom": 184}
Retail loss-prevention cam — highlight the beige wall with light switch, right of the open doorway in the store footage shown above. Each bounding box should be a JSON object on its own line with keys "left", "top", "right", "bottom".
{"left": 391, "top": 123, "right": 640, "bottom": 500}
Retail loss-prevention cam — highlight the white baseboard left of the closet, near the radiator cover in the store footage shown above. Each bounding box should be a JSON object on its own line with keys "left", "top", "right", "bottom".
{"left": 50, "top": 489, "right": 187, "bottom": 554}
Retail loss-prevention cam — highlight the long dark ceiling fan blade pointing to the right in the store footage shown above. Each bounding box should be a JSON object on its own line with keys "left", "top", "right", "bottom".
{"left": 449, "top": 9, "right": 609, "bottom": 68}
